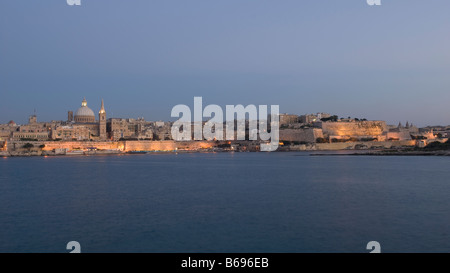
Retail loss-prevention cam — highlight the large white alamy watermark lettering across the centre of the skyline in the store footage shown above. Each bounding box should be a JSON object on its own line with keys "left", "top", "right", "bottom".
{"left": 171, "top": 97, "right": 280, "bottom": 151}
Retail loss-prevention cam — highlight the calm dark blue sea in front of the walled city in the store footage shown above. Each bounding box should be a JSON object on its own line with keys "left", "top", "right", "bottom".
{"left": 0, "top": 153, "right": 450, "bottom": 252}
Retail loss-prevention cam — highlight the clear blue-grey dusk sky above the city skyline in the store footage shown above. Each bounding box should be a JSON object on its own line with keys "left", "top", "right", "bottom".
{"left": 0, "top": 0, "right": 450, "bottom": 126}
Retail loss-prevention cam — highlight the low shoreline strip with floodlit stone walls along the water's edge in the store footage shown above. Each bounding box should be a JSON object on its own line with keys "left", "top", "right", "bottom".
{"left": 0, "top": 140, "right": 450, "bottom": 157}
